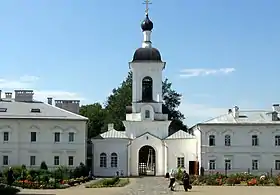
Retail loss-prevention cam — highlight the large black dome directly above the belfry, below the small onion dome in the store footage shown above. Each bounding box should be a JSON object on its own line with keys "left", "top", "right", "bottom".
{"left": 132, "top": 48, "right": 161, "bottom": 62}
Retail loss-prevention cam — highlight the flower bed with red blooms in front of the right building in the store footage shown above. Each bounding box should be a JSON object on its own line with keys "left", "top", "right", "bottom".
{"left": 188, "top": 173, "right": 280, "bottom": 186}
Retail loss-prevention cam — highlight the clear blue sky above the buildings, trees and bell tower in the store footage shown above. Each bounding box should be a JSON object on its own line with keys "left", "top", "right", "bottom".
{"left": 0, "top": 0, "right": 280, "bottom": 125}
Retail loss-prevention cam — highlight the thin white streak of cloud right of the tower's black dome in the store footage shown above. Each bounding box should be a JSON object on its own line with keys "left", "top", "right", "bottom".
{"left": 180, "top": 68, "right": 235, "bottom": 77}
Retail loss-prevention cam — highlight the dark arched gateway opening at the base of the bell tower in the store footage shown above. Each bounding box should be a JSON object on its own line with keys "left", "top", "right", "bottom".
{"left": 138, "top": 145, "right": 156, "bottom": 176}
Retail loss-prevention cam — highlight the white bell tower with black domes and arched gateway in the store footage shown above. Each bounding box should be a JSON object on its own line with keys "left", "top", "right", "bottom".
{"left": 92, "top": 11, "right": 198, "bottom": 176}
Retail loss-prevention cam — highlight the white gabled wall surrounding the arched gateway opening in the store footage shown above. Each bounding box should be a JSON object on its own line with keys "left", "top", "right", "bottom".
{"left": 130, "top": 133, "right": 165, "bottom": 176}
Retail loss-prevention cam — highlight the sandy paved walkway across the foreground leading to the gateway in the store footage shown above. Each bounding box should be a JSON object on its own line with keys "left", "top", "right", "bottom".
{"left": 20, "top": 177, "right": 280, "bottom": 195}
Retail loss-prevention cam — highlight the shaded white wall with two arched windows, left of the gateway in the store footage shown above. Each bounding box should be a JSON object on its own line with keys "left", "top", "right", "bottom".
{"left": 92, "top": 139, "right": 129, "bottom": 177}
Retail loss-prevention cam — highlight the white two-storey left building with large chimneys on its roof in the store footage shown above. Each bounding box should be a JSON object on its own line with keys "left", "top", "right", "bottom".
{"left": 0, "top": 90, "right": 87, "bottom": 169}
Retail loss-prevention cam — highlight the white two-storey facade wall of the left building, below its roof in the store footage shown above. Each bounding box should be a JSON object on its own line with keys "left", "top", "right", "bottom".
{"left": 0, "top": 119, "right": 87, "bottom": 168}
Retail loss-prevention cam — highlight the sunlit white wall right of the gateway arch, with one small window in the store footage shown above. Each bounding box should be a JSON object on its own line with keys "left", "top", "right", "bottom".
{"left": 166, "top": 139, "right": 197, "bottom": 171}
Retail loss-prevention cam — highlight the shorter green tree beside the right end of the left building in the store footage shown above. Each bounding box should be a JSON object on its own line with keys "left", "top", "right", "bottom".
{"left": 80, "top": 103, "right": 107, "bottom": 138}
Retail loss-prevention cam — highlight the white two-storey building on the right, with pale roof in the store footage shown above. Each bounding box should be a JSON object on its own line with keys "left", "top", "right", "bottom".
{"left": 193, "top": 104, "right": 280, "bottom": 174}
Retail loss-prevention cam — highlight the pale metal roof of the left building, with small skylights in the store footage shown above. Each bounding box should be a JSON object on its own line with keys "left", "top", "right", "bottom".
{"left": 0, "top": 100, "right": 88, "bottom": 120}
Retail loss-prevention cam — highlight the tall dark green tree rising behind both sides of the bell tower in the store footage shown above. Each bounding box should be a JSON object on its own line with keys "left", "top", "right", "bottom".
{"left": 105, "top": 72, "right": 187, "bottom": 134}
